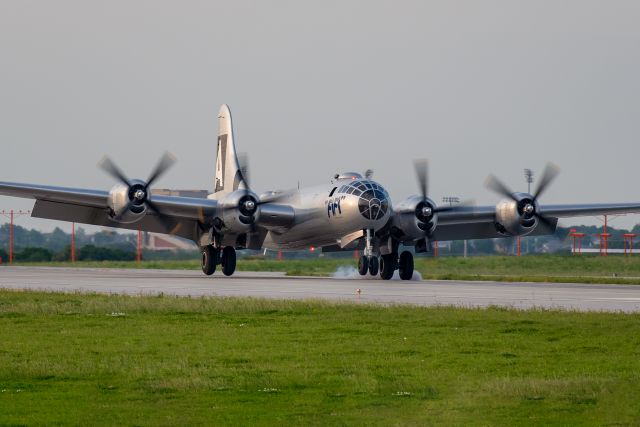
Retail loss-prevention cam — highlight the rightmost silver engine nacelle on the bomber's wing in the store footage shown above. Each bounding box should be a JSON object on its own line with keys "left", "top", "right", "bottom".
{"left": 495, "top": 193, "right": 539, "bottom": 236}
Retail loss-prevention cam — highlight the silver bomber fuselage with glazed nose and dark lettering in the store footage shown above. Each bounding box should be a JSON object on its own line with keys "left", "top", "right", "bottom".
{"left": 263, "top": 176, "right": 391, "bottom": 250}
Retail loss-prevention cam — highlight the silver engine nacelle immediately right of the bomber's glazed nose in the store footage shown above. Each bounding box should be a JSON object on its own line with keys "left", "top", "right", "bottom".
{"left": 393, "top": 196, "right": 438, "bottom": 242}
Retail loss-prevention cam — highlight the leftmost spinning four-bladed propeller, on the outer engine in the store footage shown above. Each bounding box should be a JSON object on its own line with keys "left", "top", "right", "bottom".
{"left": 98, "top": 152, "right": 179, "bottom": 234}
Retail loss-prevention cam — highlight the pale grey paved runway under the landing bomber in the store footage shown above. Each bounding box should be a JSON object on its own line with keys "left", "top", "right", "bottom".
{"left": 0, "top": 266, "right": 640, "bottom": 312}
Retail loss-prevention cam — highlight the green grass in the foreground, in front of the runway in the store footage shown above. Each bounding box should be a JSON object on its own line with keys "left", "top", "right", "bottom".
{"left": 0, "top": 291, "right": 640, "bottom": 426}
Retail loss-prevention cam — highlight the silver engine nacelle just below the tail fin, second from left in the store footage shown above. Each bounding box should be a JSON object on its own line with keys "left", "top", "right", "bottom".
{"left": 218, "top": 190, "right": 260, "bottom": 234}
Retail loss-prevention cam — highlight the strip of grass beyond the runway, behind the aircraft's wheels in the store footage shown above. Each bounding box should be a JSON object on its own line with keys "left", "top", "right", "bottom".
{"left": 11, "top": 255, "right": 640, "bottom": 284}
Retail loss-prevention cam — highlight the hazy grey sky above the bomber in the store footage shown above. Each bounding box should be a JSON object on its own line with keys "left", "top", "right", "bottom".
{"left": 0, "top": 0, "right": 640, "bottom": 234}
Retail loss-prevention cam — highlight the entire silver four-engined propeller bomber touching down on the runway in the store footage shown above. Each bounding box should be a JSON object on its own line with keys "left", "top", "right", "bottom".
{"left": 0, "top": 105, "right": 640, "bottom": 280}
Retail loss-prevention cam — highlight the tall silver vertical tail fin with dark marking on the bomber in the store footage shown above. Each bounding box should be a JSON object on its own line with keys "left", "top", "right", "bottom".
{"left": 213, "top": 104, "right": 248, "bottom": 193}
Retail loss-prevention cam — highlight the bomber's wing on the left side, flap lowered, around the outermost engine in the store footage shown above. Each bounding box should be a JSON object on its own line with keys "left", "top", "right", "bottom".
{"left": 0, "top": 182, "right": 217, "bottom": 241}
